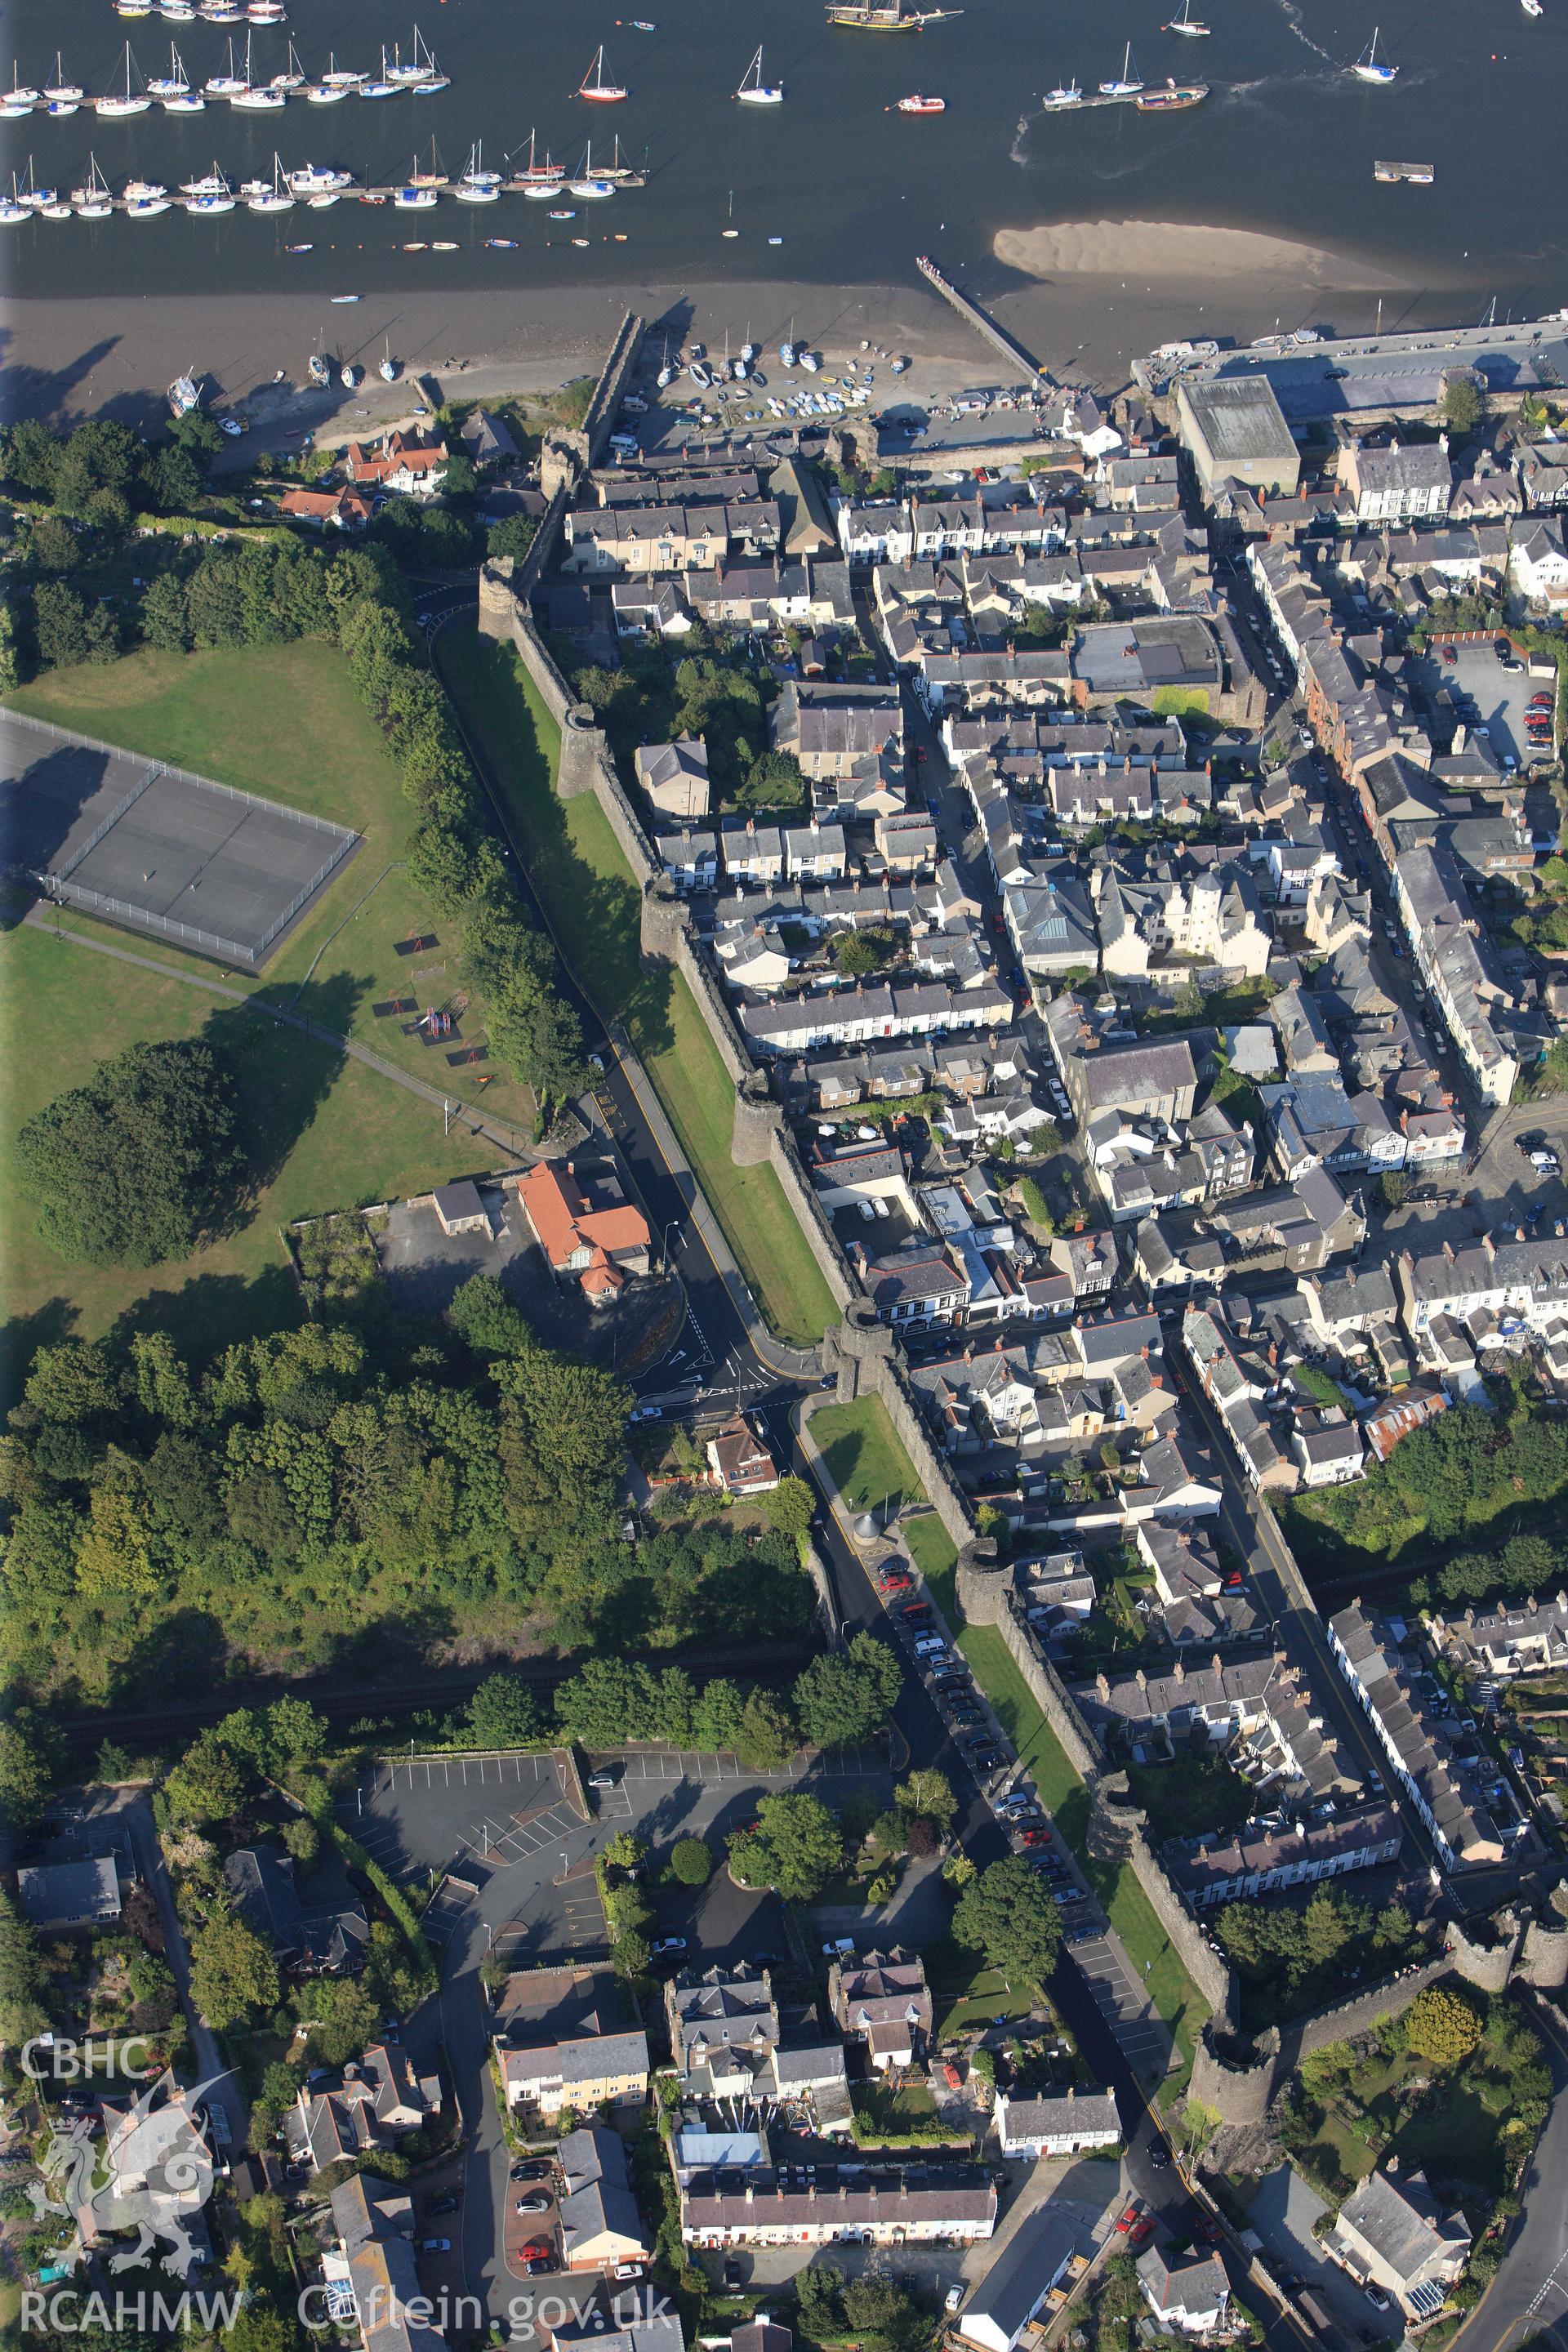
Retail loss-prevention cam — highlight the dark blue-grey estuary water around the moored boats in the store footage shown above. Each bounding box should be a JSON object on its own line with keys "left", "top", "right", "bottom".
{"left": 0, "top": 0, "right": 1568, "bottom": 324}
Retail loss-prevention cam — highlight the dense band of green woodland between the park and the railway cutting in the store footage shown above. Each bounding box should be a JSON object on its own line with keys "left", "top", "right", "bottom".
{"left": 0, "top": 1277, "right": 813, "bottom": 1735}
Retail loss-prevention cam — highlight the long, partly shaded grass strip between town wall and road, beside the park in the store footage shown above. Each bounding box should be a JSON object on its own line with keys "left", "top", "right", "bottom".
{"left": 439, "top": 628, "right": 837, "bottom": 1345}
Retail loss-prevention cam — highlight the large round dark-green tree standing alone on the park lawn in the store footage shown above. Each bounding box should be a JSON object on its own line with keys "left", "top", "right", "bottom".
{"left": 16, "top": 1037, "right": 244, "bottom": 1265}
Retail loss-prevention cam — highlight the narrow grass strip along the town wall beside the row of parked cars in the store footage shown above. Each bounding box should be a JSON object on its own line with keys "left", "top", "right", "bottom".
{"left": 959, "top": 1625, "right": 1209, "bottom": 2098}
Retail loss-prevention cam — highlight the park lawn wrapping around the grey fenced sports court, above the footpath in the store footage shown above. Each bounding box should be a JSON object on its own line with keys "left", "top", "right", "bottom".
{"left": 11, "top": 642, "right": 533, "bottom": 1136}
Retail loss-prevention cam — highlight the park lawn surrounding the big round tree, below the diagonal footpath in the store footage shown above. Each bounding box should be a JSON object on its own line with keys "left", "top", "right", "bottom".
{"left": 0, "top": 902, "right": 493, "bottom": 1379}
